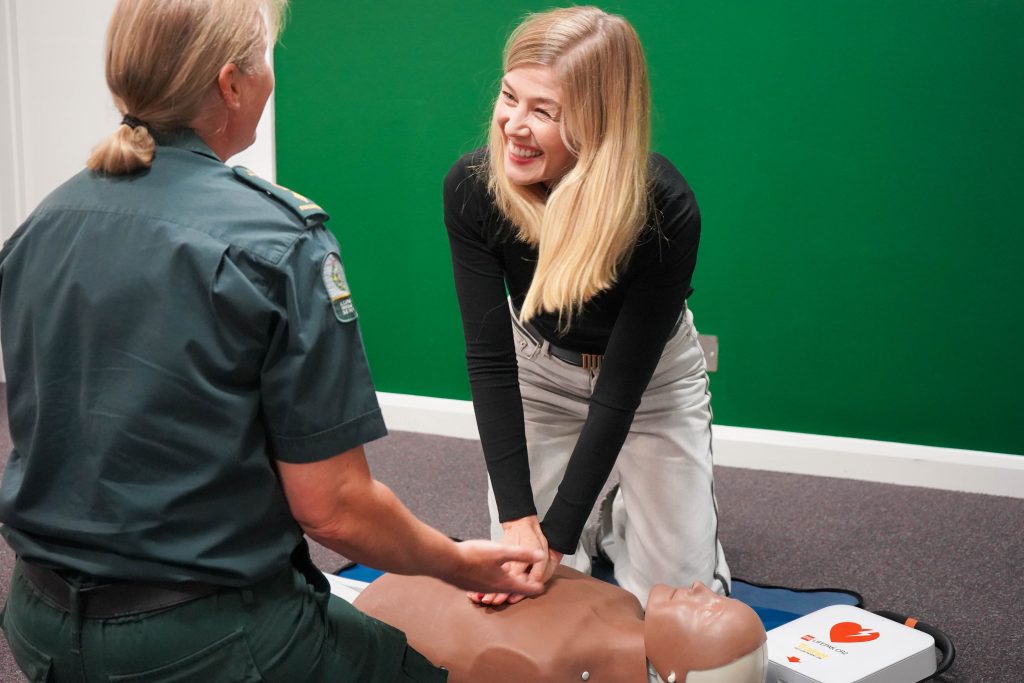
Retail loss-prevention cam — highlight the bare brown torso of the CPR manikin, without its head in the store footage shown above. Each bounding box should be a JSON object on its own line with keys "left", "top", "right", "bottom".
{"left": 355, "top": 569, "right": 647, "bottom": 683}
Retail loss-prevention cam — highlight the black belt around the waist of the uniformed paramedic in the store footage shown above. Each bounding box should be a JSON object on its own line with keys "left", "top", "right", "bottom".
{"left": 17, "top": 560, "right": 222, "bottom": 618}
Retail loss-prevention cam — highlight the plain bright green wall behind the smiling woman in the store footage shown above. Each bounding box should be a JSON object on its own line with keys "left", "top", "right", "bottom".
{"left": 276, "top": 0, "right": 1024, "bottom": 454}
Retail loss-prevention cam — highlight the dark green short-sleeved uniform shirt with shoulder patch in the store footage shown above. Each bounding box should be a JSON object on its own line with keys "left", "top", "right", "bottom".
{"left": 0, "top": 131, "right": 386, "bottom": 586}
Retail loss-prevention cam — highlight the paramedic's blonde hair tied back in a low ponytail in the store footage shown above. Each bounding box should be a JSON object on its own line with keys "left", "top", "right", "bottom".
{"left": 86, "top": 0, "right": 288, "bottom": 175}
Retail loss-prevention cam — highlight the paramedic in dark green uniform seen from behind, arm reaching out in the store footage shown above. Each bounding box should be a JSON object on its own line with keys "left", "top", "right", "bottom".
{"left": 0, "top": 0, "right": 542, "bottom": 683}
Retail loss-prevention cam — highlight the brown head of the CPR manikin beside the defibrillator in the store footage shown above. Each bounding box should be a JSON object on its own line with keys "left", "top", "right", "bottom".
{"left": 644, "top": 582, "right": 768, "bottom": 683}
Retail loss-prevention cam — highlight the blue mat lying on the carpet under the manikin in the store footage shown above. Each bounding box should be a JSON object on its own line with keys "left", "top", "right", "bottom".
{"left": 338, "top": 559, "right": 863, "bottom": 631}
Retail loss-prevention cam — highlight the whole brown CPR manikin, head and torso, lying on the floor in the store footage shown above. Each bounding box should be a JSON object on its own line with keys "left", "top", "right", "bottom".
{"left": 355, "top": 566, "right": 768, "bottom": 683}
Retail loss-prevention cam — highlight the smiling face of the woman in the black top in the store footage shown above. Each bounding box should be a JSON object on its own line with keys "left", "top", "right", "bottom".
{"left": 493, "top": 65, "right": 575, "bottom": 185}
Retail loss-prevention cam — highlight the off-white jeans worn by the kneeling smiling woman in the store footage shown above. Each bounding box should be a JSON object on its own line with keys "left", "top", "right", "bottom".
{"left": 487, "top": 310, "right": 730, "bottom": 605}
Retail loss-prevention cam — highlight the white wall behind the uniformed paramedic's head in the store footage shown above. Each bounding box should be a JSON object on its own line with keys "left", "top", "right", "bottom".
{"left": 0, "top": 0, "right": 274, "bottom": 382}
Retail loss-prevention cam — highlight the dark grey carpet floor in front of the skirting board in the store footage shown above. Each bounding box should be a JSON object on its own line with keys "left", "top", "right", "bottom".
{"left": 0, "top": 392, "right": 1024, "bottom": 683}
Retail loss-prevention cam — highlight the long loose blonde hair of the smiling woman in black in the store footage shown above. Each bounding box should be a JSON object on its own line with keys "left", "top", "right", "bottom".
{"left": 487, "top": 7, "right": 650, "bottom": 329}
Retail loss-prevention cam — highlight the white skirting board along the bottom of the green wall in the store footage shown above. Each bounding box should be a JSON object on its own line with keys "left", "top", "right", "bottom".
{"left": 377, "top": 392, "right": 1024, "bottom": 498}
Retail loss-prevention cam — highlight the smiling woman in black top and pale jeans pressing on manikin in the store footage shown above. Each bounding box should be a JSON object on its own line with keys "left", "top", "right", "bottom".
{"left": 444, "top": 7, "right": 730, "bottom": 604}
